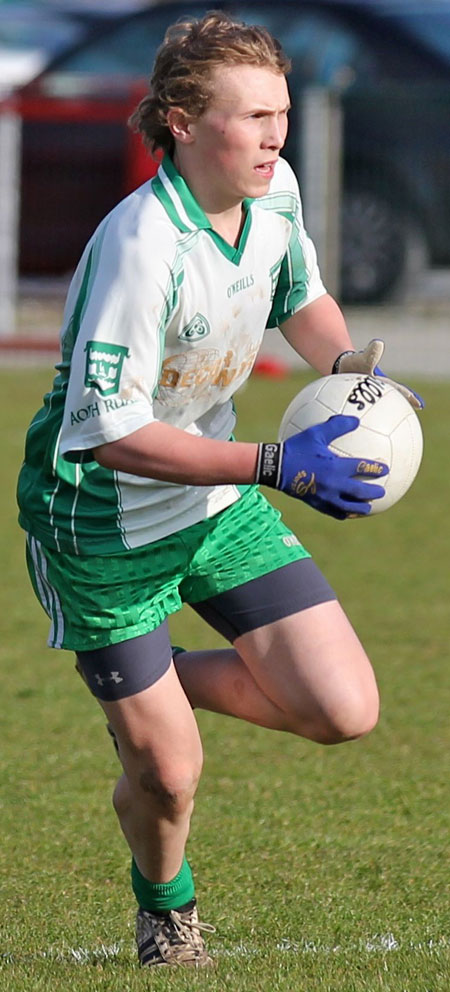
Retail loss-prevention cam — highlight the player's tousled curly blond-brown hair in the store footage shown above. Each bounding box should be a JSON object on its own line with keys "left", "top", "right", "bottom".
{"left": 128, "top": 11, "right": 291, "bottom": 153}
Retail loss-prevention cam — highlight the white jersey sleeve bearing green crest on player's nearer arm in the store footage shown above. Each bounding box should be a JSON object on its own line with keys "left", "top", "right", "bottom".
{"left": 59, "top": 204, "right": 178, "bottom": 462}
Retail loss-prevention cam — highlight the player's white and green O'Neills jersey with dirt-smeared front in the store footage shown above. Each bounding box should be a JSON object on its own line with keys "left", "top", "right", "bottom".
{"left": 19, "top": 156, "right": 325, "bottom": 555}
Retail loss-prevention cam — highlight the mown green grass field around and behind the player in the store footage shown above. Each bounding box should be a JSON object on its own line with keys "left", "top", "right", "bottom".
{"left": 0, "top": 368, "right": 450, "bottom": 992}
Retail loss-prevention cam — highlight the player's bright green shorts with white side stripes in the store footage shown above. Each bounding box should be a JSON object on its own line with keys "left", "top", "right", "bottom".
{"left": 27, "top": 487, "right": 310, "bottom": 651}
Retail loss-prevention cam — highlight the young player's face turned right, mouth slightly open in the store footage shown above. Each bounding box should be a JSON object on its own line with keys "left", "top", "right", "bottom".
{"left": 191, "top": 65, "right": 290, "bottom": 206}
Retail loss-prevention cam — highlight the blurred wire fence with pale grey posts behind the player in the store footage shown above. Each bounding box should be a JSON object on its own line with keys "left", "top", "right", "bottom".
{"left": 0, "top": 84, "right": 450, "bottom": 334}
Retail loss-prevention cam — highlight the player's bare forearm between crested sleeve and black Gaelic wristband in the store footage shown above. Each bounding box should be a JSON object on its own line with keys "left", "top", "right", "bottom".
{"left": 94, "top": 421, "right": 258, "bottom": 486}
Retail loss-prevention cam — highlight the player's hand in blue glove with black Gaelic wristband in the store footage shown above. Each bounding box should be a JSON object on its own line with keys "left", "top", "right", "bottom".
{"left": 256, "top": 414, "right": 389, "bottom": 520}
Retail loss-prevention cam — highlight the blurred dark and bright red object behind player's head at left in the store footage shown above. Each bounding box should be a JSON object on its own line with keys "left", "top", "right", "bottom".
{"left": 15, "top": 80, "right": 158, "bottom": 275}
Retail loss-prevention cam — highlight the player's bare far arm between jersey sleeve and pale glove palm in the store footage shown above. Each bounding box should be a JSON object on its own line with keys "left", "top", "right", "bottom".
{"left": 281, "top": 294, "right": 353, "bottom": 375}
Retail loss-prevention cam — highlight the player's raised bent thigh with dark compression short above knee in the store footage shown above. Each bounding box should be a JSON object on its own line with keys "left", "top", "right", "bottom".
{"left": 192, "top": 558, "right": 378, "bottom": 740}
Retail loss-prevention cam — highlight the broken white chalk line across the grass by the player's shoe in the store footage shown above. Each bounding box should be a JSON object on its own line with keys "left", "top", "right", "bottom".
{"left": 0, "top": 932, "right": 450, "bottom": 965}
